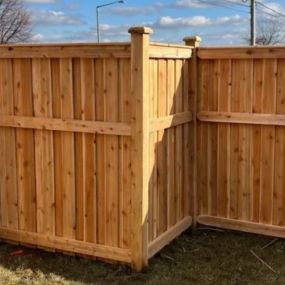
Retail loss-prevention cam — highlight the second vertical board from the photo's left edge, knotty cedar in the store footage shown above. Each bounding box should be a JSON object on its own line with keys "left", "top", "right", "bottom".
{"left": 13, "top": 59, "right": 37, "bottom": 231}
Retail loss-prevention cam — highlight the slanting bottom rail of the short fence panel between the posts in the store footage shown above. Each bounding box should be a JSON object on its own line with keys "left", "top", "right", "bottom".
{"left": 148, "top": 216, "right": 192, "bottom": 258}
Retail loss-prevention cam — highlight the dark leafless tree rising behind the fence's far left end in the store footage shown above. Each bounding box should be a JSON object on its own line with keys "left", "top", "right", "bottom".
{"left": 0, "top": 0, "right": 31, "bottom": 44}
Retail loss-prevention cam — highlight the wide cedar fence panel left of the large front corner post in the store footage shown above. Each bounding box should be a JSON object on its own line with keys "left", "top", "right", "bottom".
{"left": 0, "top": 44, "right": 132, "bottom": 263}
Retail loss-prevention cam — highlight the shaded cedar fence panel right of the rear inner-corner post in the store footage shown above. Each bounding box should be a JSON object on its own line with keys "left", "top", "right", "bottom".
{"left": 198, "top": 48, "right": 285, "bottom": 236}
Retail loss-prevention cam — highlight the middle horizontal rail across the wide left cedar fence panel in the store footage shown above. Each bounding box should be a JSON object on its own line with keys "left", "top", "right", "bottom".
{"left": 0, "top": 115, "right": 131, "bottom": 136}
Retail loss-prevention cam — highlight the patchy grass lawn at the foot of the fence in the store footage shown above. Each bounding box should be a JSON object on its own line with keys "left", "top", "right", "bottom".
{"left": 0, "top": 229, "right": 285, "bottom": 285}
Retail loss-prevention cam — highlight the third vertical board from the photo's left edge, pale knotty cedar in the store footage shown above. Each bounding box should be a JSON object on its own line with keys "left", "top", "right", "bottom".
{"left": 32, "top": 59, "right": 55, "bottom": 235}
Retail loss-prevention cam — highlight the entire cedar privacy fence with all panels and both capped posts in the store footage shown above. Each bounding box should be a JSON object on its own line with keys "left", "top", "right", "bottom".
{"left": 0, "top": 28, "right": 285, "bottom": 270}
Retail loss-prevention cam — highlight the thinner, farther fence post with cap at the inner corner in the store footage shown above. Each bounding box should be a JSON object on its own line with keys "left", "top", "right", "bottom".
{"left": 183, "top": 36, "right": 202, "bottom": 228}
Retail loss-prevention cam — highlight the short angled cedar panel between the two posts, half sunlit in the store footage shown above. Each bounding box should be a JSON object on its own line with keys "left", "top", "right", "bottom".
{"left": 148, "top": 40, "right": 193, "bottom": 256}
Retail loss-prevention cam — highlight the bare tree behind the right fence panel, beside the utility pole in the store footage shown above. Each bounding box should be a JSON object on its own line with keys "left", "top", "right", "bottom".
{"left": 256, "top": 17, "right": 285, "bottom": 45}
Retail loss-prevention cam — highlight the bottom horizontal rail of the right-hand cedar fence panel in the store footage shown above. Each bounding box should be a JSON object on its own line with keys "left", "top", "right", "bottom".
{"left": 198, "top": 216, "right": 285, "bottom": 238}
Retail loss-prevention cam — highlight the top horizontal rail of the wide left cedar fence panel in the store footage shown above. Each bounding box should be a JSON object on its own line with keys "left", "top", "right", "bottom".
{"left": 0, "top": 44, "right": 131, "bottom": 58}
